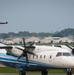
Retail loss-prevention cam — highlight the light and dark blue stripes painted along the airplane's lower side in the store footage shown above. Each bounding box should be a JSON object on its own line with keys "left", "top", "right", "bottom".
{"left": 0, "top": 53, "right": 55, "bottom": 67}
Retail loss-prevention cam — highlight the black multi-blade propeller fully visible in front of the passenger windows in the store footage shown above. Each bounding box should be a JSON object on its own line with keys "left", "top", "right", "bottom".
{"left": 18, "top": 38, "right": 36, "bottom": 64}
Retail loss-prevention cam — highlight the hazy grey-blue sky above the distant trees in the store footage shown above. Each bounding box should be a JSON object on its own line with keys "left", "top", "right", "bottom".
{"left": 0, "top": 0, "right": 74, "bottom": 33}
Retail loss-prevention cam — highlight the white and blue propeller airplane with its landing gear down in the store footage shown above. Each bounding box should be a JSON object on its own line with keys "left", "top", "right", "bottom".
{"left": 0, "top": 38, "right": 74, "bottom": 75}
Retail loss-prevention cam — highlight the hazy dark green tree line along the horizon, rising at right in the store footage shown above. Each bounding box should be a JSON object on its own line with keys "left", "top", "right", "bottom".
{"left": 0, "top": 28, "right": 74, "bottom": 39}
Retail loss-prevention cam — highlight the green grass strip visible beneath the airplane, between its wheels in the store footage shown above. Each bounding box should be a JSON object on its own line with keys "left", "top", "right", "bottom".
{"left": 0, "top": 67, "right": 65, "bottom": 74}
